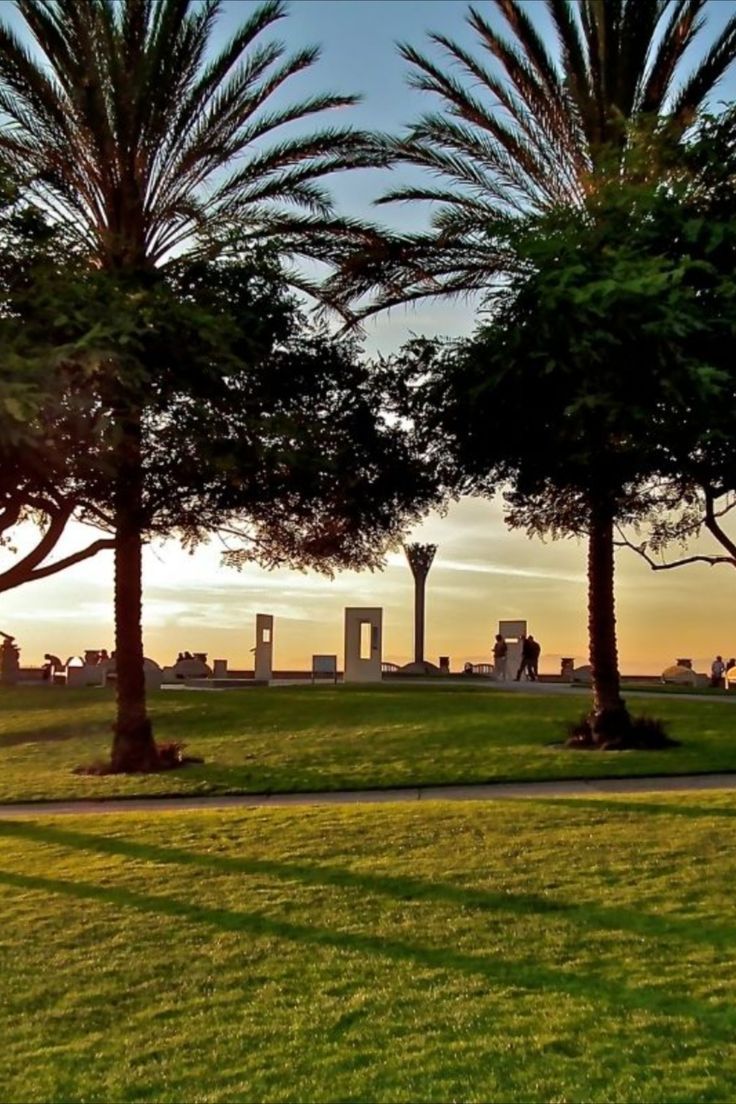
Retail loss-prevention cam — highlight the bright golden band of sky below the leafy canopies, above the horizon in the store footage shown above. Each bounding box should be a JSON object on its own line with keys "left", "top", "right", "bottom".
{"left": 0, "top": 499, "right": 736, "bottom": 675}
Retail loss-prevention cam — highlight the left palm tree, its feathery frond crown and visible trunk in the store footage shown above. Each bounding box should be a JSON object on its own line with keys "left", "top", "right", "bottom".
{"left": 0, "top": 0, "right": 377, "bottom": 771}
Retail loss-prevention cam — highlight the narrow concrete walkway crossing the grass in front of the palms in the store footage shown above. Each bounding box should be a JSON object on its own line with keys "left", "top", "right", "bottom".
{"left": 0, "top": 774, "right": 736, "bottom": 819}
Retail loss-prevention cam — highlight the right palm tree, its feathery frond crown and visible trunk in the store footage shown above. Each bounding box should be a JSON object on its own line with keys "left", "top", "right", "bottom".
{"left": 333, "top": 0, "right": 736, "bottom": 741}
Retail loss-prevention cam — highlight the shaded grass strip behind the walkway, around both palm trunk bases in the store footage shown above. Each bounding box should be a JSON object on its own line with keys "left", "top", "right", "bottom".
{"left": 0, "top": 687, "right": 736, "bottom": 800}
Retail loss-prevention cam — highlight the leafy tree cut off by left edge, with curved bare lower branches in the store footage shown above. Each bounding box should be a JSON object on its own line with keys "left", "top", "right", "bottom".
{"left": 0, "top": 188, "right": 114, "bottom": 593}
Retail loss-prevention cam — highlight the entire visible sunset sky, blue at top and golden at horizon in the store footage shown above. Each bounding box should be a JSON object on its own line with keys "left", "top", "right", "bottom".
{"left": 0, "top": 0, "right": 736, "bottom": 673}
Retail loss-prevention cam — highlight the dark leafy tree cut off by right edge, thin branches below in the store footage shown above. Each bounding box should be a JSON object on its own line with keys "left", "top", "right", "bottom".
{"left": 618, "top": 107, "right": 736, "bottom": 571}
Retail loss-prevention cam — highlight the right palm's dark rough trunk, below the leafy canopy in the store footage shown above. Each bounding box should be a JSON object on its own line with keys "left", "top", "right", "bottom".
{"left": 588, "top": 502, "right": 631, "bottom": 743}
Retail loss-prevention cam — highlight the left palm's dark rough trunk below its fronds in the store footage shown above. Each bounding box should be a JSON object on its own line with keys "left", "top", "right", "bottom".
{"left": 113, "top": 410, "right": 158, "bottom": 772}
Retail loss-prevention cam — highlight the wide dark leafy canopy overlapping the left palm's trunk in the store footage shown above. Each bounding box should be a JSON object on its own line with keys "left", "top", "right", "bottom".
{"left": 4, "top": 246, "right": 420, "bottom": 769}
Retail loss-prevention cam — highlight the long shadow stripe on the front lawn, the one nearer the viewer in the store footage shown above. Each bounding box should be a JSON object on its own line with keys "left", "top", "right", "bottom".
{"left": 0, "top": 870, "right": 735, "bottom": 1041}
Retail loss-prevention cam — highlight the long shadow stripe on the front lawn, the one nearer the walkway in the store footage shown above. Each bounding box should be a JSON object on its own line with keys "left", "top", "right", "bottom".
{"left": 0, "top": 820, "right": 736, "bottom": 949}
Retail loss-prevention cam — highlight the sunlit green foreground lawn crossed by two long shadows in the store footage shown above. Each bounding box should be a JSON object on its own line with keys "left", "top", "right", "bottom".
{"left": 0, "top": 794, "right": 736, "bottom": 1102}
